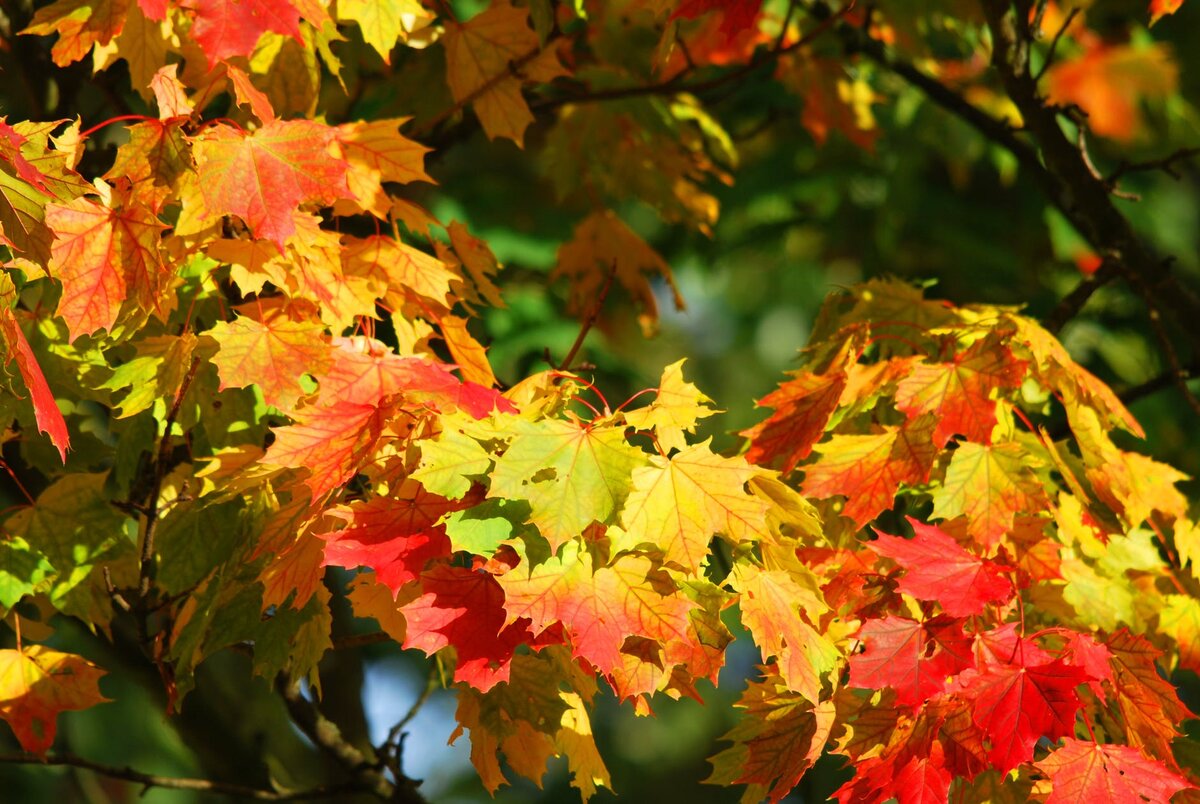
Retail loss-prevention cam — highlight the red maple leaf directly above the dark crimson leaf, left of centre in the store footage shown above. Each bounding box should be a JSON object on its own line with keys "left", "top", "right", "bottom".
{"left": 316, "top": 480, "right": 460, "bottom": 594}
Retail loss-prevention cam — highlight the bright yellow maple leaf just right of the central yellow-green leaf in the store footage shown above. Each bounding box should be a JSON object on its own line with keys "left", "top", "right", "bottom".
{"left": 612, "top": 442, "right": 767, "bottom": 575}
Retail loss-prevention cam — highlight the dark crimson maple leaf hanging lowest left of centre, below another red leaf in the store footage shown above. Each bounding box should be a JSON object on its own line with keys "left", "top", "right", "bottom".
{"left": 401, "top": 564, "right": 544, "bottom": 692}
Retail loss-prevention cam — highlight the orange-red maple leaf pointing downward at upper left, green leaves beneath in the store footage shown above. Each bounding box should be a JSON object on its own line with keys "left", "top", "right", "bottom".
{"left": 46, "top": 198, "right": 167, "bottom": 341}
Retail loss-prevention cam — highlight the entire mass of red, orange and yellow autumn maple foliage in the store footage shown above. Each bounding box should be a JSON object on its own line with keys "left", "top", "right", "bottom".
{"left": 0, "top": 0, "right": 1200, "bottom": 800}
